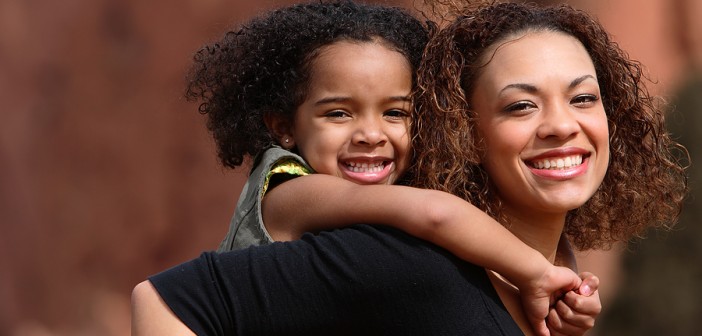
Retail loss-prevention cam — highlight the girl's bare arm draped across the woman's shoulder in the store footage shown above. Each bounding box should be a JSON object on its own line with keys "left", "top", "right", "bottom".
{"left": 262, "top": 174, "right": 580, "bottom": 335}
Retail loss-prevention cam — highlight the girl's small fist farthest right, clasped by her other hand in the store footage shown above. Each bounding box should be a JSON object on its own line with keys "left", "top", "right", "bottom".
{"left": 546, "top": 272, "right": 602, "bottom": 336}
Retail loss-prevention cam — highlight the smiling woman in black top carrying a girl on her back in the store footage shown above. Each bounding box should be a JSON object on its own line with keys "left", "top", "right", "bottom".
{"left": 133, "top": 4, "right": 686, "bottom": 335}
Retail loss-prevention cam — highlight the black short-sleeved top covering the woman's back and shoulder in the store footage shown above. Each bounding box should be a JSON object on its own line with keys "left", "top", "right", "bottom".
{"left": 151, "top": 225, "right": 521, "bottom": 335}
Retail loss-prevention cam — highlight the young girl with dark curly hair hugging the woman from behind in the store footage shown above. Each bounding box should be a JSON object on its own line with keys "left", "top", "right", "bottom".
{"left": 169, "top": 2, "right": 599, "bottom": 334}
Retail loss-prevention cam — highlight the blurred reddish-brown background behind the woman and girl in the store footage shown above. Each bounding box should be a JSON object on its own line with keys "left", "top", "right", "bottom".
{"left": 0, "top": 0, "right": 702, "bottom": 336}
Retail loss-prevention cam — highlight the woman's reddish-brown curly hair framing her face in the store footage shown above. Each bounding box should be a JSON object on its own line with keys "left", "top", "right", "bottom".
{"left": 412, "top": 3, "right": 688, "bottom": 250}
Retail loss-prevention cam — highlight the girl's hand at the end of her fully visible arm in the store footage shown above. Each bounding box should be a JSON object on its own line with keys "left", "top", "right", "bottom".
{"left": 518, "top": 264, "right": 580, "bottom": 336}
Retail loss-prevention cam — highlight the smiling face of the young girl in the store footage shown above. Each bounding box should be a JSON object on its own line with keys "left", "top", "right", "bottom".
{"left": 284, "top": 41, "right": 412, "bottom": 184}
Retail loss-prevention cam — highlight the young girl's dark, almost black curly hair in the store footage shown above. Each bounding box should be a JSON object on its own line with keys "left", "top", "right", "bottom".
{"left": 186, "top": 1, "right": 428, "bottom": 168}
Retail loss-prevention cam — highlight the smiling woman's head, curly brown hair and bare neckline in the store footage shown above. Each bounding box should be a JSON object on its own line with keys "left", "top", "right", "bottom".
{"left": 415, "top": 4, "right": 686, "bottom": 329}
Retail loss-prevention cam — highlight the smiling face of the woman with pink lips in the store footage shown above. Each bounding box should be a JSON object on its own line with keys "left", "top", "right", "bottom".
{"left": 471, "top": 32, "right": 609, "bottom": 218}
